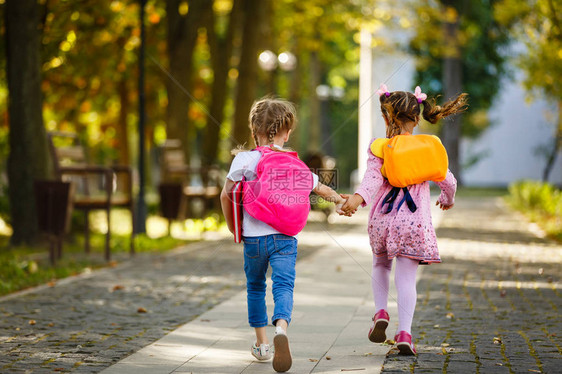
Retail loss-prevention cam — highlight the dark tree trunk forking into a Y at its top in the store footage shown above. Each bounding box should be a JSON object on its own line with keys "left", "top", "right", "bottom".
{"left": 201, "top": 0, "right": 241, "bottom": 166}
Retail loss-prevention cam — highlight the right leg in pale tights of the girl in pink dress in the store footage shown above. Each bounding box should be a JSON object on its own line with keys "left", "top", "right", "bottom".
{"left": 394, "top": 257, "right": 419, "bottom": 334}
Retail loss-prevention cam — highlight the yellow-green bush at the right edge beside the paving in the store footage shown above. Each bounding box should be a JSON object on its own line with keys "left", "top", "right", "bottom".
{"left": 507, "top": 180, "right": 562, "bottom": 240}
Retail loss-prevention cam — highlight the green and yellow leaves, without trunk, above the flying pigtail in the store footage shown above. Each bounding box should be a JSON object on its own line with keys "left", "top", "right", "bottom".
{"left": 410, "top": 0, "right": 509, "bottom": 137}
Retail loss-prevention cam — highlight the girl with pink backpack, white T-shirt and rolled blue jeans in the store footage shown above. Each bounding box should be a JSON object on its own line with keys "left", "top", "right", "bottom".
{"left": 221, "top": 98, "right": 345, "bottom": 372}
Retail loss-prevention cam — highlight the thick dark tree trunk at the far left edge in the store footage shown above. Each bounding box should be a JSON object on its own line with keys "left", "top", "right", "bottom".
{"left": 5, "top": 0, "right": 49, "bottom": 244}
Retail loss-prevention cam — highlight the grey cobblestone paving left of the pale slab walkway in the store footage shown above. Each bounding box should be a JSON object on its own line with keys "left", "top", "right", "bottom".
{"left": 0, "top": 238, "right": 318, "bottom": 373}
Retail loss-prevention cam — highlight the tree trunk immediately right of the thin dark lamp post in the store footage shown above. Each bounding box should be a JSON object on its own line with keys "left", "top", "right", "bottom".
{"left": 166, "top": 0, "right": 206, "bottom": 162}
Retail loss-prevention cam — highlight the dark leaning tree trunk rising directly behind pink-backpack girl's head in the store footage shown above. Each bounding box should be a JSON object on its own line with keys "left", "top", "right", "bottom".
{"left": 231, "top": 0, "right": 269, "bottom": 147}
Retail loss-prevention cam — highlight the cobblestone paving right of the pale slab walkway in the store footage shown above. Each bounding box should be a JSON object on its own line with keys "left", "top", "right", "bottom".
{"left": 382, "top": 199, "right": 562, "bottom": 373}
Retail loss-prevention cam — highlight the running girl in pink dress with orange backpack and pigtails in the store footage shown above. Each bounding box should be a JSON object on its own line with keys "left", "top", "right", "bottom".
{"left": 342, "top": 84, "right": 467, "bottom": 355}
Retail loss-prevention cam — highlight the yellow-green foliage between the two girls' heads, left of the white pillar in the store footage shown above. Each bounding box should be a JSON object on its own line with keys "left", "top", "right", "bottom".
{"left": 270, "top": 0, "right": 366, "bottom": 186}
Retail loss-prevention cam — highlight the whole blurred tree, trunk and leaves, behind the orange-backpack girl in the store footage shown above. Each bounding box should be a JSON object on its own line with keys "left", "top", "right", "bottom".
{"left": 410, "top": 0, "right": 510, "bottom": 181}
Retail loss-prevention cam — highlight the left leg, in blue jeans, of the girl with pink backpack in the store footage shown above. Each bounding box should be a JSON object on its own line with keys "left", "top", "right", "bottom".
{"left": 244, "top": 237, "right": 268, "bottom": 345}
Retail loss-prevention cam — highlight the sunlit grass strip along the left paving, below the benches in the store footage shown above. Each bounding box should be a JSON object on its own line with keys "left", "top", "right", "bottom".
{"left": 0, "top": 210, "right": 224, "bottom": 296}
